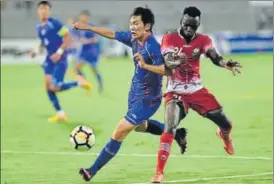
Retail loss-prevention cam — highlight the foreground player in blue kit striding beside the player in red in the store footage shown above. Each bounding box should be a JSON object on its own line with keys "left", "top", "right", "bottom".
{"left": 74, "top": 7, "right": 186, "bottom": 181}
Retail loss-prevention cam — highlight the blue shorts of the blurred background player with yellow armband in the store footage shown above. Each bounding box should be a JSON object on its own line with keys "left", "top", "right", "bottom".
{"left": 42, "top": 61, "right": 68, "bottom": 86}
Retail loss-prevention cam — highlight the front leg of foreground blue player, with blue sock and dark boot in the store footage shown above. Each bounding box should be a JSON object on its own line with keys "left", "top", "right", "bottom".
{"left": 79, "top": 119, "right": 136, "bottom": 181}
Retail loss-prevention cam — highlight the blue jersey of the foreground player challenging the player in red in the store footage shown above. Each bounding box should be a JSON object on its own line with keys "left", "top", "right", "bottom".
{"left": 115, "top": 32, "right": 164, "bottom": 101}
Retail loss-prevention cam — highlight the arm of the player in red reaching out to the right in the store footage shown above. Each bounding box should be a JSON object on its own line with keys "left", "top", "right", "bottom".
{"left": 206, "top": 48, "right": 242, "bottom": 76}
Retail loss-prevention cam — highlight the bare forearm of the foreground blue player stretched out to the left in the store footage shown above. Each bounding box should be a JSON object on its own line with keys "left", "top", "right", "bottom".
{"left": 73, "top": 22, "right": 115, "bottom": 39}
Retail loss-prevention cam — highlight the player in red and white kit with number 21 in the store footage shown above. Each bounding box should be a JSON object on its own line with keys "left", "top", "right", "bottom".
{"left": 152, "top": 7, "right": 241, "bottom": 183}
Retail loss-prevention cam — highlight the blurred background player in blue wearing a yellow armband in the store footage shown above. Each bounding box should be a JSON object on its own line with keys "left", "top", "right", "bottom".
{"left": 30, "top": 1, "right": 90, "bottom": 122}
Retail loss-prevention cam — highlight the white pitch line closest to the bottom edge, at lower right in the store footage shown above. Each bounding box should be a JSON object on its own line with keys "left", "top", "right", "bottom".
{"left": 132, "top": 172, "right": 273, "bottom": 184}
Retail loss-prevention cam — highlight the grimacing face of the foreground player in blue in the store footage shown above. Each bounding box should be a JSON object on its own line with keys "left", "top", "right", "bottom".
{"left": 129, "top": 16, "right": 149, "bottom": 39}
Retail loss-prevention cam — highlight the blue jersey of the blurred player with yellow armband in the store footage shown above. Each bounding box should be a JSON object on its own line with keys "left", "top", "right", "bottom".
{"left": 36, "top": 18, "right": 68, "bottom": 62}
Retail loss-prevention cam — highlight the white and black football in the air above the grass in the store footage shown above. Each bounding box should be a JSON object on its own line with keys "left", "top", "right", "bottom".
{"left": 70, "top": 125, "right": 95, "bottom": 151}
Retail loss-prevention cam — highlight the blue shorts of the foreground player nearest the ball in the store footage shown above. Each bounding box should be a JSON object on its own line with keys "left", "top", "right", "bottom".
{"left": 125, "top": 97, "right": 161, "bottom": 125}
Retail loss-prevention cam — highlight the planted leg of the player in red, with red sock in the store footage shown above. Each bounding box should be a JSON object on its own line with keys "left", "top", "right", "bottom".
{"left": 151, "top": 99, "right": 187, "bottom": 183}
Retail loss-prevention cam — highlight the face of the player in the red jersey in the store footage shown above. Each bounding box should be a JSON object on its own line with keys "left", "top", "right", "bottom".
{"left": 181, "top": 15, "right": 200, "bottom": 37}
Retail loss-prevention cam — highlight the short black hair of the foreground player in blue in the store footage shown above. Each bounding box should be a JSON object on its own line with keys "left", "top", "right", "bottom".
{"left": 131, "top": 7, "right": 155, "bottom": 31}
